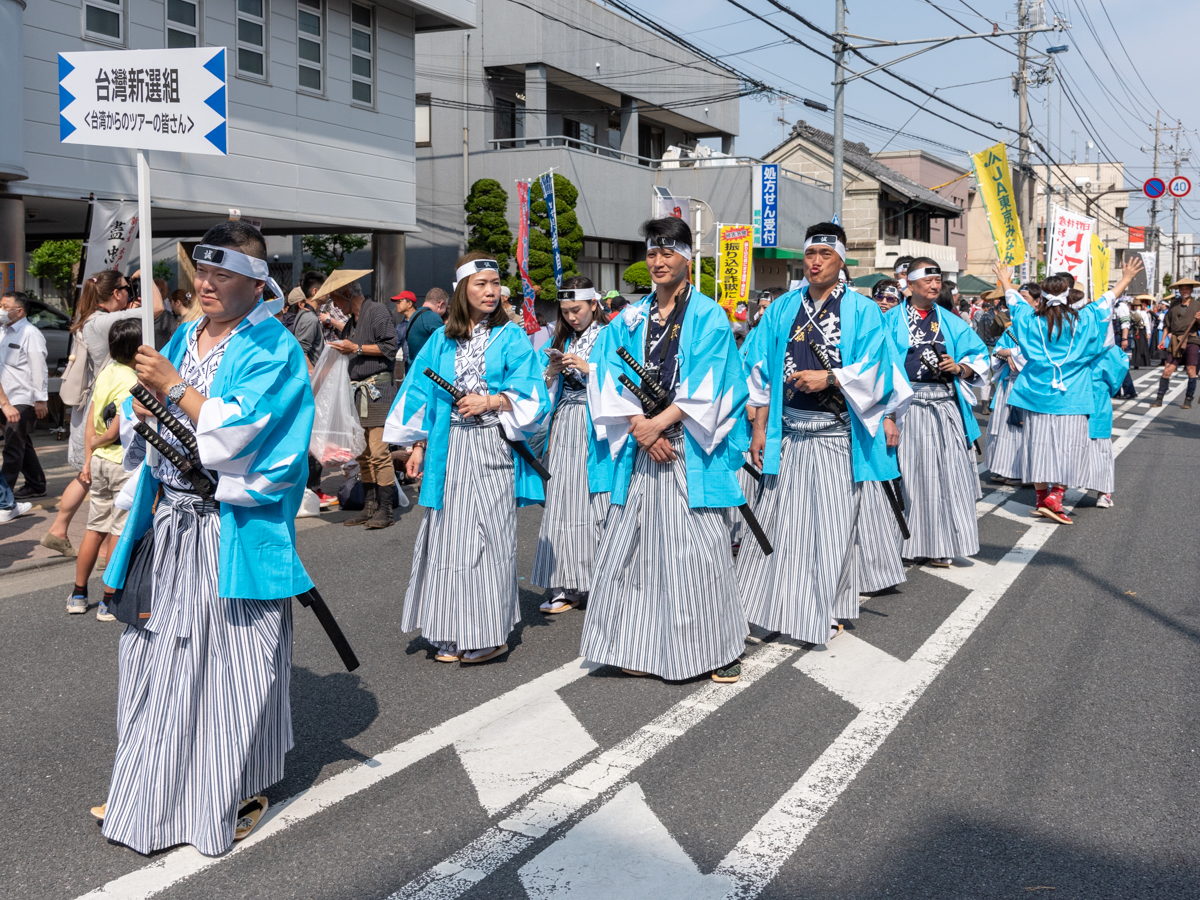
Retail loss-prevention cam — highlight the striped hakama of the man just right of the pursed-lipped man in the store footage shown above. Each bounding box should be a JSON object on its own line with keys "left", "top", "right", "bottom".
{"left": 898, "top": 382, "right": 983, "bottom": 559}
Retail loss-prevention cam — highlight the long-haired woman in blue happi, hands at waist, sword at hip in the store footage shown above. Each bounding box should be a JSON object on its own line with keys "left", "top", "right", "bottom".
{"left": 384, "top": 251, "right": 550, "bottom": 662}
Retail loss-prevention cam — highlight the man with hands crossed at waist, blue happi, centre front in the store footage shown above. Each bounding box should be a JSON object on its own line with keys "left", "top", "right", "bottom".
{"left": 581, "top": 218, "right": 749, "bottom": 683}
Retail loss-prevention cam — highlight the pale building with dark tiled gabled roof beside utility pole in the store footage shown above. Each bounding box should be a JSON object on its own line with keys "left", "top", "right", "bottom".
{"left": 766, "top": 120, "right": 966, "bottom": 277}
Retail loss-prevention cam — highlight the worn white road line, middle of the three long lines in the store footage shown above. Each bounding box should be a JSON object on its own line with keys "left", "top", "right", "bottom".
{"left": 388, "top": 643, "right": 797, "bottom": 900}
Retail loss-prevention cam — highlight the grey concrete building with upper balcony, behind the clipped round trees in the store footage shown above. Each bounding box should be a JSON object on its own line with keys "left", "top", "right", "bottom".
{"left": 408, "top": 0, "right": 832, "bottom": 300}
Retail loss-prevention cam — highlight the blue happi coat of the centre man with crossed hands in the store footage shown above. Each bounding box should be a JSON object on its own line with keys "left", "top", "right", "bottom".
{"left": 588, "top": 288, "right": 746, "bottom": 509}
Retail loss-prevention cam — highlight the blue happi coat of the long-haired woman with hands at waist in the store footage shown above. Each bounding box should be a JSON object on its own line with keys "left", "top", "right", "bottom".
{"left": 383, "top": 322, "right": 550, "bottom": 509}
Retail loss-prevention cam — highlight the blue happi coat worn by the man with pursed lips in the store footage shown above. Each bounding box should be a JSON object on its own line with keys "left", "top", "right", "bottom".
{"left": 744, "top": 286, "right": 900, "bottom": 481}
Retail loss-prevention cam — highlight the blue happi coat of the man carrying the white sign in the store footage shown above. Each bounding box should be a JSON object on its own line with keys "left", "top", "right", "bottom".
{"left": 104, "top": 302, "right": 313, "bottom": 600}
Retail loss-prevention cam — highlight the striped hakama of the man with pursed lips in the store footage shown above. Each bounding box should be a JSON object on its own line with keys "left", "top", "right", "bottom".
{"left": 737, "top": 409, "right": 858, "bottom": 644}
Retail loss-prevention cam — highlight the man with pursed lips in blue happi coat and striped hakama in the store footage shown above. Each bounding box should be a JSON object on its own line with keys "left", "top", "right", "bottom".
{"left": 738, "top": 222, "right": 900, "bottom": 644}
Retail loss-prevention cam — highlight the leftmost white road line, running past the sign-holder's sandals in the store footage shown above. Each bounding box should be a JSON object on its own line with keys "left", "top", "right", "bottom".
{"left": 79, "top": 659, "right": 599, "bottom": 900}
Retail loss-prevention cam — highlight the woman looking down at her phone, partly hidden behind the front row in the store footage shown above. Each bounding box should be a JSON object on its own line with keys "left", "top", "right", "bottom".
{"left": 529, "top": 275, "right": 612, "bottom": 614}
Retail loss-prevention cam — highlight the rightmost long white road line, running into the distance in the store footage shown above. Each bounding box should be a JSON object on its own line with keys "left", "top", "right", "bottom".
{"left": 714, "top": 384, "right": 1183, "bottom": 900}
